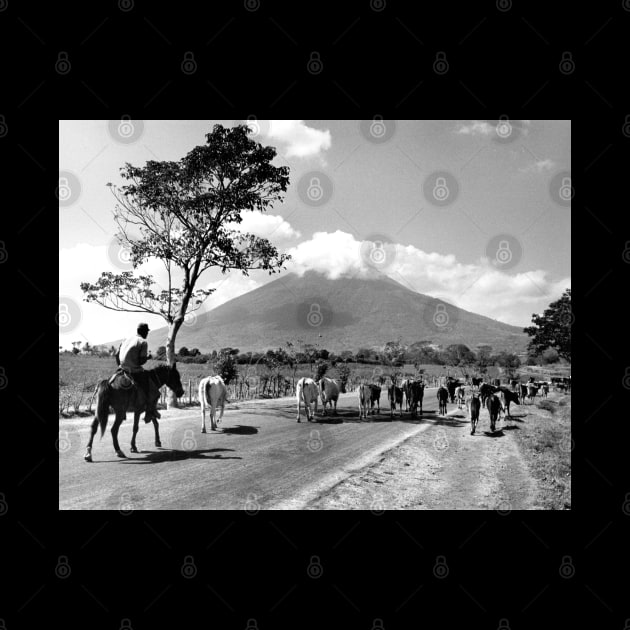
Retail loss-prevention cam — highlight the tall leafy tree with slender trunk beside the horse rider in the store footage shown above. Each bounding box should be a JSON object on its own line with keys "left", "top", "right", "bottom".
{"left": 81, "top": 125, "right": 289, "bottom": 405}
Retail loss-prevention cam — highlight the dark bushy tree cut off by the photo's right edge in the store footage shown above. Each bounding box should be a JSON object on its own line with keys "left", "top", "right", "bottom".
{"left": 524, "top": 289, "right": 573, "bottom": 362}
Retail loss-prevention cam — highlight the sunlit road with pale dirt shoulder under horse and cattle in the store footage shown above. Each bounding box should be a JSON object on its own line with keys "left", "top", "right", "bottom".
{"left": 59, "top": 389, "right": 535, "bottom": 511}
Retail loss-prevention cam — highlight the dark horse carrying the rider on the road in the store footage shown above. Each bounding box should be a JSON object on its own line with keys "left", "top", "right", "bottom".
{"left": 84, "top": 364, "right": 184, "bottom": 462}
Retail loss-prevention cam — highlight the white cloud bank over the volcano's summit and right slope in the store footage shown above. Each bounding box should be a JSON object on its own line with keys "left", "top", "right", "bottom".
{"left": 288, "top": 231, "right": 571, "bottom": 326}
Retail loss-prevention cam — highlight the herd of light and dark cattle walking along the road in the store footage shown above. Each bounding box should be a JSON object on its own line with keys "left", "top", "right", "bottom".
{"left": 199, "top": 376, "right": 571, "bottom": 435}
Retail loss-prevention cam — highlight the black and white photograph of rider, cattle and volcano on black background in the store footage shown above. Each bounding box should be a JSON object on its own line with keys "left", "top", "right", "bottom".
{"left": 59, "top": 116, "right": 574, "bottom": 514}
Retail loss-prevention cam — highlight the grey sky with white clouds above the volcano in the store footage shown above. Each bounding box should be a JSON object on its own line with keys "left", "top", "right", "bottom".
{"left": 58, "top": 117, "right": 572, "bottom": 348}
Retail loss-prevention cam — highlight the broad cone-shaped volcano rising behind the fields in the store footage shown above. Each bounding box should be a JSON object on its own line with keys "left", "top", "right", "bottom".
{"left": 138, "top": 272, "right": 528, "bottom": 352}
